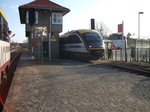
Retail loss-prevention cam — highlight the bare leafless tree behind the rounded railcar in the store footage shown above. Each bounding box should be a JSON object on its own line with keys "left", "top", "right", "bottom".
{"left": 95, "top": 22, "right": 111, "bottom": 38}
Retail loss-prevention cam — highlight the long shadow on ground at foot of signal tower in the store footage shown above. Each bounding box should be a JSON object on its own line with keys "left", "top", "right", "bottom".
{"left": 18, "top": 51, "right": 91, "bottom": 68}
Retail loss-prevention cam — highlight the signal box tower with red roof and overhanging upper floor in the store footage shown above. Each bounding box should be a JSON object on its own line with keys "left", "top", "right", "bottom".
{"left": 19, "top": 0, "right": 70, "bottom": 60}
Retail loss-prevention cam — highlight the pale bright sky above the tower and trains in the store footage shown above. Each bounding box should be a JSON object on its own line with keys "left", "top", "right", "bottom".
{"left": 0, "top": 0, "right": 150, "bottom": 42}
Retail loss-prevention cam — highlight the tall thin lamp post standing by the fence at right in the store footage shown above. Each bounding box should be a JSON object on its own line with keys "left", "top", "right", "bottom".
{"left": 136, "top": 12, "right": 144, "bottom": 61}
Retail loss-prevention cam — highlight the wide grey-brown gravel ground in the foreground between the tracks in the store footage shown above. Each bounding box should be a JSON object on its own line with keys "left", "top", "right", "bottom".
{"left": 3, "top": 52, "right": 150, "bottom": 112}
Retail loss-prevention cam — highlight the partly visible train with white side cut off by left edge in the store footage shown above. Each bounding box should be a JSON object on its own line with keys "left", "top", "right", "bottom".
{"left": 0, "top": 10, "right": 10, "bottom": 85}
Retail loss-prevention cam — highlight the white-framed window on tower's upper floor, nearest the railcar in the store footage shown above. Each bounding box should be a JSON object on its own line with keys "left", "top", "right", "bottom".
{"left": 52, "top": 13, "right": 62, "bottom": 24}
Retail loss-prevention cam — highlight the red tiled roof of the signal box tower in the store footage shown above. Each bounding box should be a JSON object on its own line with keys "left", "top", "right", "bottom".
{"left": 19, "top": 0, "right": 70, "bottom": 12}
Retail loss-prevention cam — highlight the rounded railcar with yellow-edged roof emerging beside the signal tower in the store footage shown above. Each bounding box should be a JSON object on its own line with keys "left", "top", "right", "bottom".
{"left": 60, "top": 29, "right": 104, "bottom": 61}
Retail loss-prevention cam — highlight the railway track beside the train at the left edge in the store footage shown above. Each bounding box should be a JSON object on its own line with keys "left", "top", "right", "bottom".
{"left": 0, "top": 49, "right": 23, "bottom": 112}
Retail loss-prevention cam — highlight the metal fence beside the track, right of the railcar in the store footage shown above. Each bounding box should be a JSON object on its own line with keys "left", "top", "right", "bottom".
{"left": 105, "top": 39, "right": 150, "bottom": 63}
